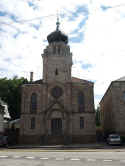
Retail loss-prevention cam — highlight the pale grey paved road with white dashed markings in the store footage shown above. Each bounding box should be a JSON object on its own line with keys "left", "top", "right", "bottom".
{"left": 0, "top": 149, "right": 125, "bottom": 166}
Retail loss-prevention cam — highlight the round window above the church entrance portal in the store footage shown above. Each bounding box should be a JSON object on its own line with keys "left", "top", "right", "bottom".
{"left": 51, "top": 86, "right": 63, "bottom": 98}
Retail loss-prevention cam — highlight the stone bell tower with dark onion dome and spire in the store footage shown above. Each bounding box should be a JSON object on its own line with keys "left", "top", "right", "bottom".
{"left": 42, "top": 18, "right": 72, "bottom": 82}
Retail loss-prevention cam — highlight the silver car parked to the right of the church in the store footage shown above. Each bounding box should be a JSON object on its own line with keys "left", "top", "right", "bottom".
{"left": 107, "top": 134, "right": 122, "bottom": 145}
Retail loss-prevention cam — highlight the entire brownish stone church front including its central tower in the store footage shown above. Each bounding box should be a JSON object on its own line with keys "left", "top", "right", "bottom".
{"left": 20, "top": 23, "right": 96, "bottom": 144}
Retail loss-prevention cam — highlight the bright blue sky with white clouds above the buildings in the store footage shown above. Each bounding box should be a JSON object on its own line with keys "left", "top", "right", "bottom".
{"left": 0, "top": 0, "right": 125, "bottom": 107}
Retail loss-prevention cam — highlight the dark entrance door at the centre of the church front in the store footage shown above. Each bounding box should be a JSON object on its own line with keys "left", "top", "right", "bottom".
{"left": 51, "top": 118, "right": 62, "bottom": 135}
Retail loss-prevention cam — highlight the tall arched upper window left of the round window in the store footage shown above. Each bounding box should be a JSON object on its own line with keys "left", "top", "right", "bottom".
{"left": 30, "top": 93, "right": 37, "bottom": 113}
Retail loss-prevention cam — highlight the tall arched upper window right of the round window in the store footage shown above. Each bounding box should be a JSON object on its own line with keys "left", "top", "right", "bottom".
{"left": 78, "top": 92, "right": 85, "bottom": 112}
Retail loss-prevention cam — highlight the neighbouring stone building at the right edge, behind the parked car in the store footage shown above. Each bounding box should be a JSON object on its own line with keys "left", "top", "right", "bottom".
{"left": 100, "top": 77, "right": 125, "bottom": 136}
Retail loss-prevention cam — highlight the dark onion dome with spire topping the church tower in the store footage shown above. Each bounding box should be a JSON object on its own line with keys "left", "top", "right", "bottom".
{"left": 47, "top": 18, "right": 68, "bottom": 44}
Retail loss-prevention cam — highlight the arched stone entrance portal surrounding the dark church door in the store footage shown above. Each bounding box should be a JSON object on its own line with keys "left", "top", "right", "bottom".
{"left": 45, "top": 109, "right": 70, "bottom": 144}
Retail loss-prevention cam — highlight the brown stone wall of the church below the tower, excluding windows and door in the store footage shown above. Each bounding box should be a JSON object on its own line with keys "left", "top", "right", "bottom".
{"left": 20, "top": 82, "right": 96, "bottom": 143}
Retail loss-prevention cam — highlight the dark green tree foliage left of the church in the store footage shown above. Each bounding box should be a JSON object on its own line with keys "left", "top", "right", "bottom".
{"left": 0, "top": 76, "right": 28, "bottom": 119}
